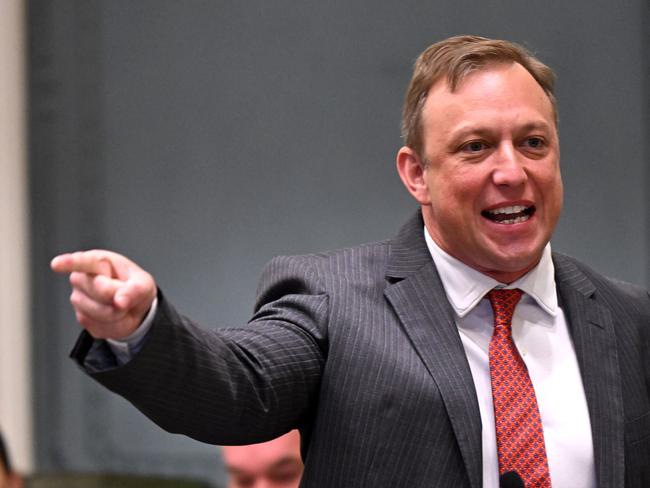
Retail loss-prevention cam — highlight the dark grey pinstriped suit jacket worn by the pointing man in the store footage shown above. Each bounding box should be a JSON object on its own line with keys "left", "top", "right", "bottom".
{"left": 73, "top": 213, "right": 650, "bottom": 488}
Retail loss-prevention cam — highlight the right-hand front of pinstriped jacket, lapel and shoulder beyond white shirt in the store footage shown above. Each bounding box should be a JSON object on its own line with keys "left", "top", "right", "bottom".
{"left": 554, "top": 255, "right": 650, "bottom": 488}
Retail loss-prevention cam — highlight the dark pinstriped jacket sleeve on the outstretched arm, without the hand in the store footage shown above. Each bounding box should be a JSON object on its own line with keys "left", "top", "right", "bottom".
{"left": 71, "top": 257, "right": 328, "bottom": 444}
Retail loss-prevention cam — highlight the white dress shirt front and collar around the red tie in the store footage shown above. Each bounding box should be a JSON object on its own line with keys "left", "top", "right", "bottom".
{"left": 424, "top": 229, "right": 596, "bottom": 488}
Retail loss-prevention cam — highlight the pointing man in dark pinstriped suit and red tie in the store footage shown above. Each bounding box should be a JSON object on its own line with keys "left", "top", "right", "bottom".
{"left": 52, "top": 36, "right": 650, "bottom": 488}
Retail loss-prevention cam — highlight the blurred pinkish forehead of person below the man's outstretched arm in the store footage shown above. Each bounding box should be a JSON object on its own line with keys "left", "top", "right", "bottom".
{"left": 223, "top": 430, "right": 303, "bottom": 488}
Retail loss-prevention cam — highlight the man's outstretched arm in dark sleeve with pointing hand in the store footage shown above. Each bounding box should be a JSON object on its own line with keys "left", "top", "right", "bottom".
{"left": 52, "top": 250, "right": 328, "bottom": 444}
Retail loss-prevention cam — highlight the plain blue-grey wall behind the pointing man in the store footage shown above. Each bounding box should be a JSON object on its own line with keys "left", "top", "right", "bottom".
{"left": 28, "top": 0, "right": 650, "bottom": 483}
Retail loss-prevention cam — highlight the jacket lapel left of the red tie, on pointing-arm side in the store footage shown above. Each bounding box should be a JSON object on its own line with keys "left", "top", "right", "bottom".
{"left": 385, "top": 212, "right": 482, "bottom": 488}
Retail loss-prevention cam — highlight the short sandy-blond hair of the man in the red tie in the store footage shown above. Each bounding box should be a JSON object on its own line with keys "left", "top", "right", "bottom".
{"left": 402, "top": 36, "right": 557, "bottom": 157}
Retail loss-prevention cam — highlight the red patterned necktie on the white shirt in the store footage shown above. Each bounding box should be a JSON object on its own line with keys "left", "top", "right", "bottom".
{"left": 488, "top": 289, "right": 551, "bottom": 488}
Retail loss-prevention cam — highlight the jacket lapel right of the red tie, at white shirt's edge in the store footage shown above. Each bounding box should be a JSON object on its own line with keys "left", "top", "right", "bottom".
{"left": 553, "top": 255, "right": 625, "bottom": 488}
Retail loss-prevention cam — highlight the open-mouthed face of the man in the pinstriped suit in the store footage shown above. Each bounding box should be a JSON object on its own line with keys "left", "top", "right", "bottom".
{"left": 404, "top": 63, "right": 562, "bottom": 283}
